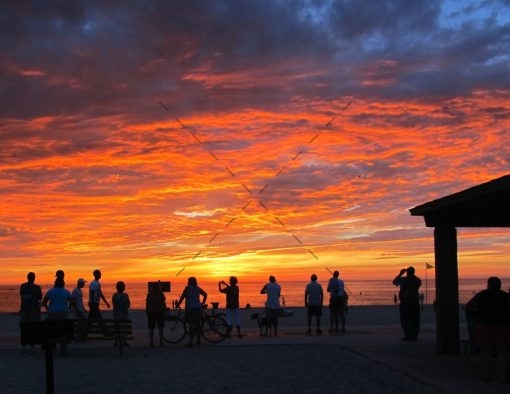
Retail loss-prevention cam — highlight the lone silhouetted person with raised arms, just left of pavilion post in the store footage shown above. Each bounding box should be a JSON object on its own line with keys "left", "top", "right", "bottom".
{"left": 393, "top": 267, "right": 421, "bottom": 341}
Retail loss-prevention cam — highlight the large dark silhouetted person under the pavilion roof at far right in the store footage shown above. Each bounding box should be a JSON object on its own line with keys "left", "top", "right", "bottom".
{"left": 466, "top": 276, "right": 510, "bottom": 381}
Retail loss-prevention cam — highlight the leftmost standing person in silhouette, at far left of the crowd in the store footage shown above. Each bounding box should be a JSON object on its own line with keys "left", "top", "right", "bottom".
{"left": 19, "top": 272, "right": 42, "bottom": 352}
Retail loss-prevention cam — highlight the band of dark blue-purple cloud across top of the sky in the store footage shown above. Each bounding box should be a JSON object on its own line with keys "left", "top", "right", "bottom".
{"left": 0, "top": 0, "right": 510, "bottom": 118}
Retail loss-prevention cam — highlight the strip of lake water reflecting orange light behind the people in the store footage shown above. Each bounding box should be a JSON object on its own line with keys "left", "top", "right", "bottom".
{"left": 0, "top": 278, "right": 510, "bottom": 312}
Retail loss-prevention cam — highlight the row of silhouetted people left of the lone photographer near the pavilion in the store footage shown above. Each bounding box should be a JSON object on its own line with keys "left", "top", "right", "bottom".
{"left": 16, "top": 269, "right": 347, "bottom": 354}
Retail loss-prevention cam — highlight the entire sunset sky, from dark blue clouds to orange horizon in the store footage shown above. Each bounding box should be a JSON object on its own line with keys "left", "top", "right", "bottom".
{"left": 0, "top": 0, "right": 510, "bottom": 283}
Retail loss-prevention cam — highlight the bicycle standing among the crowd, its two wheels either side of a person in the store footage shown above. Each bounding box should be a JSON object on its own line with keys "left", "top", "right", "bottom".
{"left": 163, "top": 302, "right": 227, "bottom": 344}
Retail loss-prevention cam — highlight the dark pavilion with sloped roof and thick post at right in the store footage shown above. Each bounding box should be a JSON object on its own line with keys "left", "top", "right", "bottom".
{"left": 410, "top": 175, "right": 510, "bottom": 354}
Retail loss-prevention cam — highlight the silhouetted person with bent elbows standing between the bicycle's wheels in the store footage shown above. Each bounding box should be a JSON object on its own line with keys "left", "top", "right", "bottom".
{"left": 176, "top": 276, "right": 207, "bottom": 347}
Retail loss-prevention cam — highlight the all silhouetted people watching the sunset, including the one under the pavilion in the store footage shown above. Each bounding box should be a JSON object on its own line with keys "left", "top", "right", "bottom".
{"left": 19, "top": 266, "right": 510, "bottom": 379}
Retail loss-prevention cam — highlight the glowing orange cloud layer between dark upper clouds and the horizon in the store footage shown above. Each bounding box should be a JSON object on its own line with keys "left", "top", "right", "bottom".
{"left": 0, "top": 92, "right": 510, "bottom": 282}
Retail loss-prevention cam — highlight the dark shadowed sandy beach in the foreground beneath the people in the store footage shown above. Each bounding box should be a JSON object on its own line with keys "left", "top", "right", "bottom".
{"left": 0, "top": 306, "right": 510, "bottom": 393}
